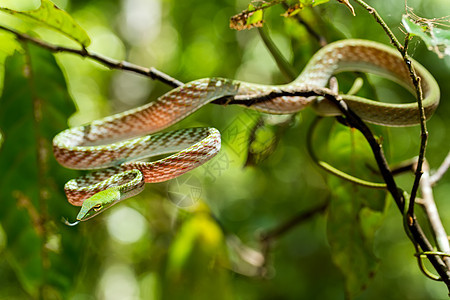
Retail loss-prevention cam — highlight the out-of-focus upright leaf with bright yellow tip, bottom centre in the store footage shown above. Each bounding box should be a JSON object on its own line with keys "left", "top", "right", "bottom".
{"left": 166, "top": 204, "right": 233, "bottom": 299}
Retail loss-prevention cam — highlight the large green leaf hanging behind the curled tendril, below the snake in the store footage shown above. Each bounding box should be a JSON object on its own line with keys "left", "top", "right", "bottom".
{"left": 327, "top": 125, "right": 386, "bottom": 298}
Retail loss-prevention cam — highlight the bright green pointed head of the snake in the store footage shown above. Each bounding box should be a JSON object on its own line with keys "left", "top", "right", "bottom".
{"left": 77, "top": 187, "right": 122, "bottom": 221}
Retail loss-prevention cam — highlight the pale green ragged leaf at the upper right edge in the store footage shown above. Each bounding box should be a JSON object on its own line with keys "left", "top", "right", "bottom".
{"left": 402, "top": 14, "right": 450, "bottom": 58}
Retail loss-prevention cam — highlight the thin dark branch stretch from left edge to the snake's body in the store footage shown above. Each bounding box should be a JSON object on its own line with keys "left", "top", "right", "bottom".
{"left": 0, "top": 25, "right": 183, "bottom": 87}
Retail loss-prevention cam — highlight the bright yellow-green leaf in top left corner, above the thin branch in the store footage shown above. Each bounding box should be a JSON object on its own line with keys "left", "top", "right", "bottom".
{"left": 0, "top": 0, "right": 91, "bottom": 47}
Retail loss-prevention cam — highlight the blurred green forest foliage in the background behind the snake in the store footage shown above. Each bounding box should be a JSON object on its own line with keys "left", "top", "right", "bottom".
{"left": 0, "top": 0, "right": 450, "bottom": 300}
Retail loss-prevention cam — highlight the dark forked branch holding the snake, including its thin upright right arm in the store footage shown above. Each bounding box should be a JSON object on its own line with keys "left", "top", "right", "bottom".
{"left": 0, "top": 9, "right": 450, "bottom": 287}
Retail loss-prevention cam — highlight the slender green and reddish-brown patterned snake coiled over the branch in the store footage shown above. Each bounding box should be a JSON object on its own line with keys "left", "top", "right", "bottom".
{"left": 53, "top": 39, "right": 440, "bottom": 224}
